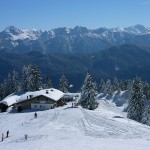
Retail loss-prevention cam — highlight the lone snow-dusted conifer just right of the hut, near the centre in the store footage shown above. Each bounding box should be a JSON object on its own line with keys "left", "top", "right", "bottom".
{"left": 79, "top": 73, "right": 98, "bottom": 110}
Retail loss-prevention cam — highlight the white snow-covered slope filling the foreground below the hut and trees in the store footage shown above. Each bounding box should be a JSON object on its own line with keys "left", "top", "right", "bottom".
{"left": 0, "top": 100, "right": 150, "bottom": 150}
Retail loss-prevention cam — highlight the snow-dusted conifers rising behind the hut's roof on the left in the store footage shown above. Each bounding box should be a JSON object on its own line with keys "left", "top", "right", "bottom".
{"left": 0, "top": 65, "right": 69, "bottom": 100}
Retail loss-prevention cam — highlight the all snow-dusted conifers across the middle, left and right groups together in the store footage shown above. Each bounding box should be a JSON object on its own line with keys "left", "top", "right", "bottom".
{"left": 0, "top": 65, "right": 150, "bottom": 125}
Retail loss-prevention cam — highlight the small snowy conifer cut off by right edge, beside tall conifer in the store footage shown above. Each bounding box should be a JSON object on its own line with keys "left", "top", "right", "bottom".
{"left": 141, "top": 106, "right": 150, "bottom": 126}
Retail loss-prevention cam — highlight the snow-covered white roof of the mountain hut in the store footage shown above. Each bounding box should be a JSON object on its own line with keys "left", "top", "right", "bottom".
{"left": 0, "top": 88, "right": 64, "bottom": 106}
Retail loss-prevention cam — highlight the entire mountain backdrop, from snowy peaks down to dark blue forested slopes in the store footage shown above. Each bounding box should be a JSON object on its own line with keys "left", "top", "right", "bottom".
{"left": 0, "top": 25, "right": 150, "bottom": 91}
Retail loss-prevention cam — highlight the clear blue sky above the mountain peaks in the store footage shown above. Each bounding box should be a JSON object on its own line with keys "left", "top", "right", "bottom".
{"left": 0, "top": 0, "right": 150, "bottom": 31}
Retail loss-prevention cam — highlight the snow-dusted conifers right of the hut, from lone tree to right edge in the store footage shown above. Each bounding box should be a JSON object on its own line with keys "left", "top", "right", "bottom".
{"left": 79, "top": 73, "right": 150, "bottom": 125}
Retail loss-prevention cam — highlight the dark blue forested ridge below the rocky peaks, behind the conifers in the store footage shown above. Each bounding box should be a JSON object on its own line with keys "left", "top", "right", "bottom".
{"left": 0, "top": 44, "right": 150, "bottom": 91}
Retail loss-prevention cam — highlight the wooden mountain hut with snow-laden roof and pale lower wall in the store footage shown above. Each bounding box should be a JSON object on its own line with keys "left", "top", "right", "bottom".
{"left": 0, "top": 88, "right": 64, "bottom": 111}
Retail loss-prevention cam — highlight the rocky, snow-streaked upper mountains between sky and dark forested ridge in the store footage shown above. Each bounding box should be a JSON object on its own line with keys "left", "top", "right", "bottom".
{"left": 0, "top": 25, "right": 150, "bottom": 53}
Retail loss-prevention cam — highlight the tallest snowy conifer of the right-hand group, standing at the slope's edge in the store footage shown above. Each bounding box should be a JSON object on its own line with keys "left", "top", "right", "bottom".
{"left": 127, "top": 77, "right": 145, "bottom": 122}
